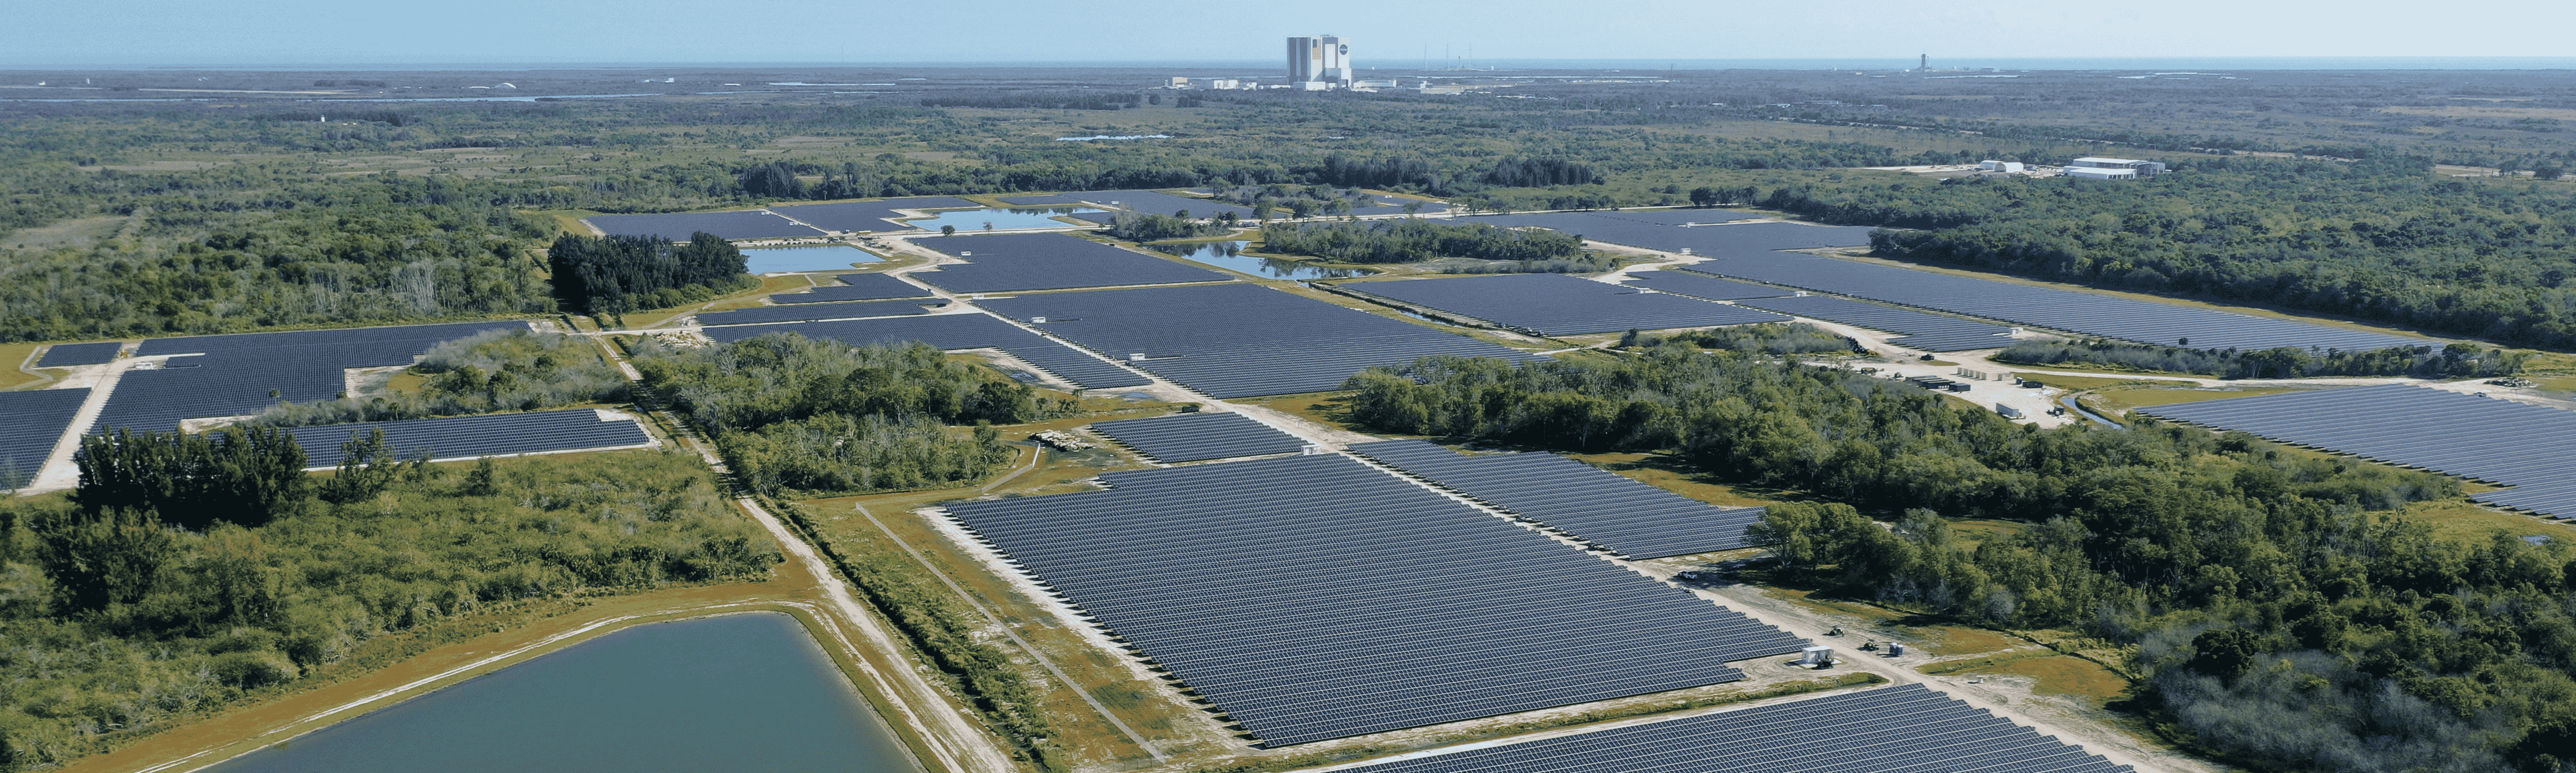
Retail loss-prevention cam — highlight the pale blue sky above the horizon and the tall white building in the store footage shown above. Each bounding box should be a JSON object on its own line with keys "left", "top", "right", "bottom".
{"left": 0, "top": 0, "right": 2576, "bottom": 67}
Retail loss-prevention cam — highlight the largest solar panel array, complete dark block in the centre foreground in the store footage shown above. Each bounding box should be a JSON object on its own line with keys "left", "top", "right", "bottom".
{"left": 948, "top": 454, "right": 1803, "bottom": 747}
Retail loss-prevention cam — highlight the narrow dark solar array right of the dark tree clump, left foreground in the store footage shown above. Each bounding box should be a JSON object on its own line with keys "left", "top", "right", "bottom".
{"left": 286, "top": 410, "right": 652, "bottom": 469}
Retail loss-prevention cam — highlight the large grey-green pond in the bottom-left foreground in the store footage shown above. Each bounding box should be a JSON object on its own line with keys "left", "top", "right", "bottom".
{"left": 206, "top": 613, "right": 914, "bottom": 773}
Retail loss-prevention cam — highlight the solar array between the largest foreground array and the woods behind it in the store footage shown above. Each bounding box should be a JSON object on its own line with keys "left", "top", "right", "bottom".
{"left": 1350, "top": 441, "right": 1788, "bottom": 559}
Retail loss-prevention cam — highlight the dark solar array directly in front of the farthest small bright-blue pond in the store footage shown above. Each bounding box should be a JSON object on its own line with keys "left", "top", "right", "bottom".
{"left": 912, "top": 235, "right": 1234, "bottom": 294}
